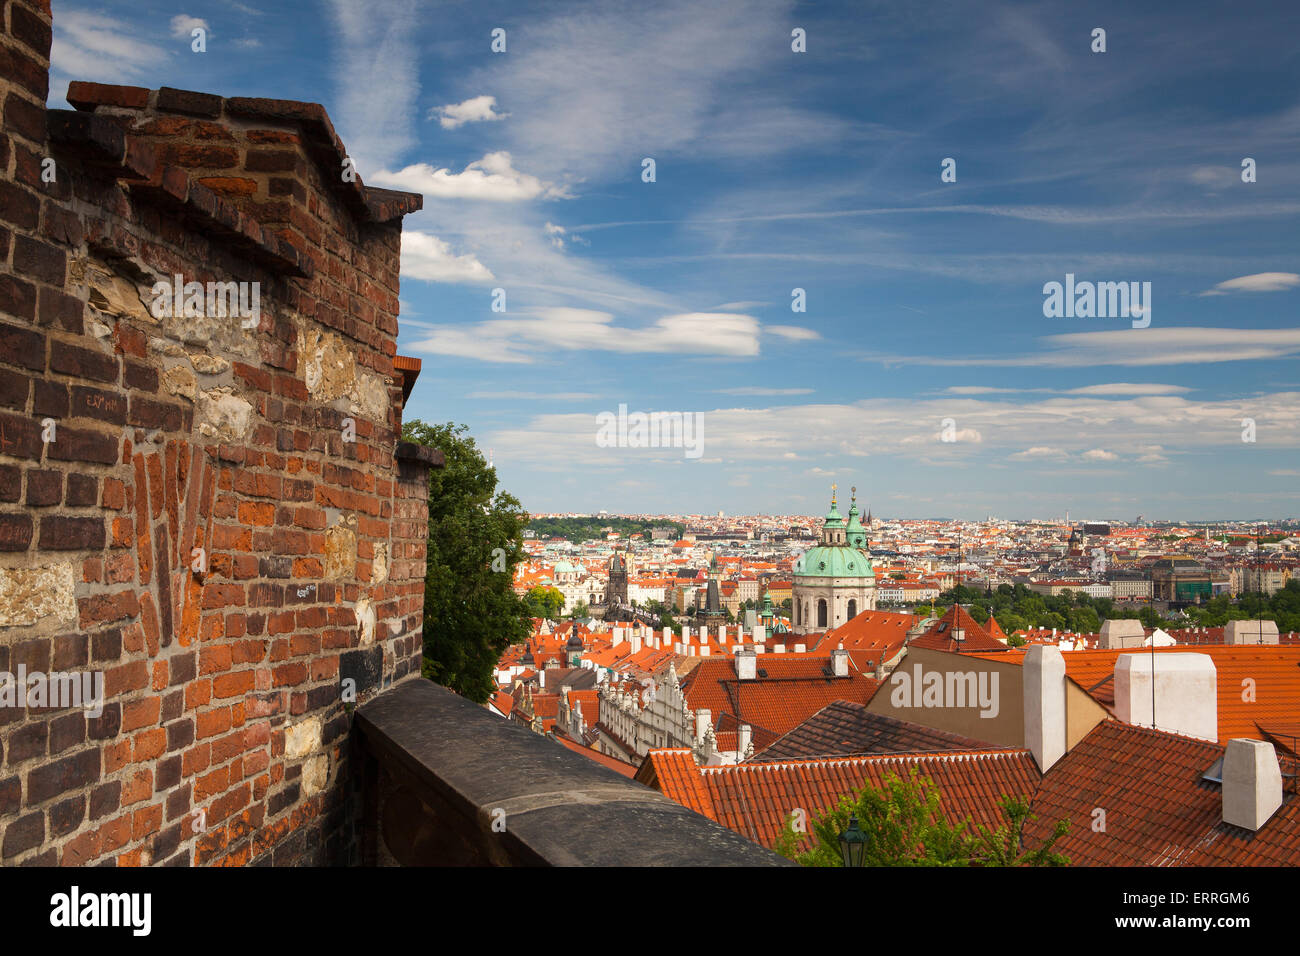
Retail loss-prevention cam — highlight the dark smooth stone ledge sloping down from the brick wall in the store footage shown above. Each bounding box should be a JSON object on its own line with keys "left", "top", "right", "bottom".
{"left": 355, "top": 679, "right": 793, "bottom": 866}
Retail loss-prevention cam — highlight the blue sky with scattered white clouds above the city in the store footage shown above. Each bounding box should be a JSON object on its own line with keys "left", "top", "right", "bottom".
{"left": 51, "top": 0, "right": 1300, "bottom": 519}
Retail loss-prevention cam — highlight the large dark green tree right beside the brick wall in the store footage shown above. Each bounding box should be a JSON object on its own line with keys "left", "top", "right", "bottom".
{"left": 402, "top": 419, "right": 530, "bottom": 704}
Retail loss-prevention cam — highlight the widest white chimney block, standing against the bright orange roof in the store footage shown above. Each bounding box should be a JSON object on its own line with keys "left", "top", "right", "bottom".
{"left": 1115, "top": 653, "right": 1218, "bottom": 740}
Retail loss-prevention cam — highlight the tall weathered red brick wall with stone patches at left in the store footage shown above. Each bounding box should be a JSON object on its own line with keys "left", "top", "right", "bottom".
{"left": 0, "top": 0, "right": 438, "bottom": 865}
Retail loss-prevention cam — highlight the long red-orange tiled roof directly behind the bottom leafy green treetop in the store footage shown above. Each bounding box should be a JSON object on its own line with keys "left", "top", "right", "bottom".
{"left": 637, "top": 750, "right": 1039, "bottom": 847}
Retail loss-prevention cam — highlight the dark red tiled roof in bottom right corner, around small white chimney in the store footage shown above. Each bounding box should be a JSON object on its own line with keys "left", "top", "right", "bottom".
{"left": 1024, "top": 721, "right": 1300, "bottom": 866}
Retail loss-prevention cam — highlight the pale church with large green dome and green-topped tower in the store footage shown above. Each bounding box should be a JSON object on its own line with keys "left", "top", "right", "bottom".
{"left": 790, "top": 485, "right": 876, "bottom": 633}
